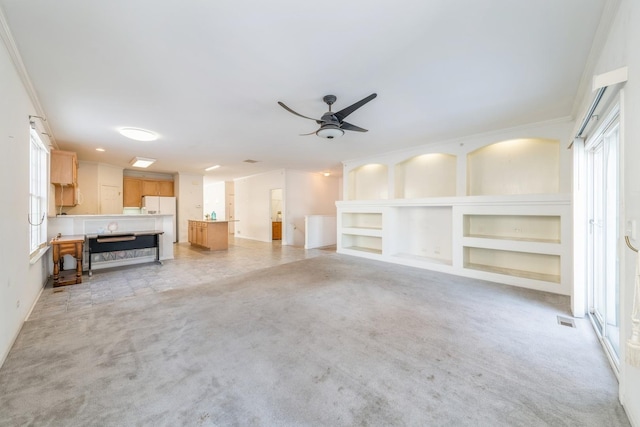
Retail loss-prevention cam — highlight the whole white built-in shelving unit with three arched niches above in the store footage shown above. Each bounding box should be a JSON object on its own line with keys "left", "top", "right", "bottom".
{"left": 336, "top": 138, "right": 572, "bottom": 295}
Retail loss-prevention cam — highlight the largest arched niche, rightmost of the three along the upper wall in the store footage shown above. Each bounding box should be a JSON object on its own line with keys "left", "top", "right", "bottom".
{"left": 467, "top": 138, "right": 560, "bottom": 196}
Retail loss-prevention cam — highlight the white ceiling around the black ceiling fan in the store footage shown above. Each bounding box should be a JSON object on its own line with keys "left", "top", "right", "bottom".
{"left": 0, "top": 0, "right": 610, "bottom": 179}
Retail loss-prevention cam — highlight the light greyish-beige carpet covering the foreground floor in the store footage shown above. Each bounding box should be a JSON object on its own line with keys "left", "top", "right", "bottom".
{"left": 0, "top": 254, "right": 629, "bottom": 426}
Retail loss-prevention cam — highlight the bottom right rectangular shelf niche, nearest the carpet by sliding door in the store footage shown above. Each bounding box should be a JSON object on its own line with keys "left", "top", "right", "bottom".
{"left": 464, "top": 247, "right": 561, "bottom": 283}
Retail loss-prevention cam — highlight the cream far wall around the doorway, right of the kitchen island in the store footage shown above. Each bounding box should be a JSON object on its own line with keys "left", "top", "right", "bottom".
{"left": 234, "top": 169, "right": 286, "bottom": 244}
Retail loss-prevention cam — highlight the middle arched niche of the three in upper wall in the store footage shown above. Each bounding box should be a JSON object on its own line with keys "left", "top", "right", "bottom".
{"left": 395, "top": 153, "right": 457, "bottom": 199}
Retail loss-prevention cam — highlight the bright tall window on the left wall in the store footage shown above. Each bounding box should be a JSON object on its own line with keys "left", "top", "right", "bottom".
{"left": 29, "top": 128, "right": 49, "bottom": 256}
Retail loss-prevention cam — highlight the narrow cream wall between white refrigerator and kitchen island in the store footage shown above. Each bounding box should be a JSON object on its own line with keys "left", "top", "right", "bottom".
{"left": 174, "top": 173, "right": 204, "bottom": 242}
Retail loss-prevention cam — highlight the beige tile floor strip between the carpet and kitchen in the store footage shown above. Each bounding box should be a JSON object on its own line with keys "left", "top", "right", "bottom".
{"left": 27, "top": 237, "right": 335, "bottom": 320}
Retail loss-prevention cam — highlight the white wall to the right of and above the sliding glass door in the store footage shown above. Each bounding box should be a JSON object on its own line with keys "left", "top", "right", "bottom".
{"left": 583, "top": 0, "right": 640, "bottom": 426}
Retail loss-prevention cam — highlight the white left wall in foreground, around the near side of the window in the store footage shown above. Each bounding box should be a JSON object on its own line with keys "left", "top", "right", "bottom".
{"left": 0, "top": 31, "right": 51, "bottom": 365}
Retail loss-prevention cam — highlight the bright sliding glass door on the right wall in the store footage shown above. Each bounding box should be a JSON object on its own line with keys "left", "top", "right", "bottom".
{"left": 585, "top": 106, "right": 620, "bottom": 368}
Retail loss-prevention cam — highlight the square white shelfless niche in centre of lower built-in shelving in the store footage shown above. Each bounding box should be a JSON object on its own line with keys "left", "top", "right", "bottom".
{"left": 394, "top": 206, "right": 453, "bottom": 265}
